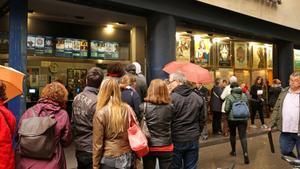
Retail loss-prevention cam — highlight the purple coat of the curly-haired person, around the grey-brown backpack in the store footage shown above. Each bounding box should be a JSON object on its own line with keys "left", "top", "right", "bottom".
{"left": 16, "top": 100, "right": 72, "bottom": 169}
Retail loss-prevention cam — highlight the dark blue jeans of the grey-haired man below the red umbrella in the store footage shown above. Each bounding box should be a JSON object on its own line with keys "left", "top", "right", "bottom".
{"left": 172, "top": 140, "right": 199, "bottom": 169}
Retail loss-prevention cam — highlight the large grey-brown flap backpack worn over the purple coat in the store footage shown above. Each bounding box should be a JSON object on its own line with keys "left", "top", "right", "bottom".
{"left": 18, "top": 108, "right": 56, "bottom": 160}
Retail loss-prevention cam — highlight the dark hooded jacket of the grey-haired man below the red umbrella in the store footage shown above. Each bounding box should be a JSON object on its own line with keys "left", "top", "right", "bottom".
{"left": 171, "top": 85, "right": 206, "bottom": 142}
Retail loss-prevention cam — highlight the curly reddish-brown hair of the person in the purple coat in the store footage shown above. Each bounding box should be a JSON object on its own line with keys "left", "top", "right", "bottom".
{"left": 41, "top": 82, "right": 68, "bottom": 105}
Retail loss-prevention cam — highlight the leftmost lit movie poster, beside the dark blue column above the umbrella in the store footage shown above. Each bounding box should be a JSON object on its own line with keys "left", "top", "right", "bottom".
{"left": 176, "top": 36, "right": 191, "bottom": 61}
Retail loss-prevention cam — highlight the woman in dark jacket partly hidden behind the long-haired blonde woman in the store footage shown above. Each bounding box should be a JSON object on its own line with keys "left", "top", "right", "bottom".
{"left": 119, "top": 74, "right": 141, "bottom": 120}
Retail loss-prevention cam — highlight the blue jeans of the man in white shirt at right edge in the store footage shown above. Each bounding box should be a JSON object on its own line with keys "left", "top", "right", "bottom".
{"left": 279, "top": 132, "right": 300, "bottom": 159}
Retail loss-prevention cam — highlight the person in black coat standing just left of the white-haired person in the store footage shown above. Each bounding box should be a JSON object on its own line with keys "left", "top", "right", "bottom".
{"left": 210, "top": 78, "right": 223, "bottom": 134}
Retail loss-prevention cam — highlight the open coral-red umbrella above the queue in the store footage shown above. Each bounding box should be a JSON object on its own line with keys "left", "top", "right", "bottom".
{"left": 163, "top": 61, "right": 213, "bottom": 84}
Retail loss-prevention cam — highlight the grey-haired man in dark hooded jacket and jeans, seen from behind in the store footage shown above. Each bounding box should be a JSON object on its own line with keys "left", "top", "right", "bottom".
{"left": 169, "top": 73, "right": 206, "bottom": 169}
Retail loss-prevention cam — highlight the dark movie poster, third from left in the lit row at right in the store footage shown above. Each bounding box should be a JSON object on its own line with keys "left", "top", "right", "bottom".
{"left": 218, "top": 42, "right": 231, "bottom": 67}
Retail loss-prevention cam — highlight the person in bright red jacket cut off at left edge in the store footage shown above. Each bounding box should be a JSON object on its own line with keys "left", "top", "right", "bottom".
{"left": 0, "top": 81, "right": 16, "bottom": 169}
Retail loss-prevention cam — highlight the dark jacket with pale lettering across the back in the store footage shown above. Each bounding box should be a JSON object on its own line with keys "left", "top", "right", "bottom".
{"left": 72, "top": 86, "right": 99, "bottom": 153}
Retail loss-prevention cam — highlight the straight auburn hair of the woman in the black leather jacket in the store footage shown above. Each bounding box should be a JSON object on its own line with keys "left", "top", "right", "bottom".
{"left": 145, "top": 79, "right": 171, "bottom": 104}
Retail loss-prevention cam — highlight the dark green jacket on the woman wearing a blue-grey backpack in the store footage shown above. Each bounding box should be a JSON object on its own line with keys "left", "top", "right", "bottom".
{"left": 225, "top": 87, "right": 249, "bottom": 121}
